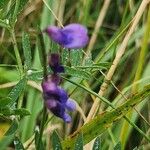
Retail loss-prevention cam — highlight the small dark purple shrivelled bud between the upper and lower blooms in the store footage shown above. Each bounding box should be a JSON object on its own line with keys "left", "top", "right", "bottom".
{"left": 49, "top": 53, "right": 64, "bottom": 74}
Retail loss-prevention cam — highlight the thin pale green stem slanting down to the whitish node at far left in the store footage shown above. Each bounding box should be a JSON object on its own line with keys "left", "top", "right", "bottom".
{"left": 10, "top": 30, "right": 23, "bottom": 77}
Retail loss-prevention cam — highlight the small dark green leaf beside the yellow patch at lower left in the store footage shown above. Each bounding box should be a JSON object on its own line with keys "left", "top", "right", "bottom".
{"left": 5, "top": 120, "right": 18, "bottom": 136}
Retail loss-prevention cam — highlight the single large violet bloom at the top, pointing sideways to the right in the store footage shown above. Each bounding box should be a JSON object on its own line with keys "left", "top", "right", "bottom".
{"left": 45, "top": 24, "right": 89, "bottom": 49}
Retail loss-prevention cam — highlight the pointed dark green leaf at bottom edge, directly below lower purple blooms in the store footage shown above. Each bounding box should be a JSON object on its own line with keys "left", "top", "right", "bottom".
{"left": 52, "top": 131, "right": 62, "bottom": 150}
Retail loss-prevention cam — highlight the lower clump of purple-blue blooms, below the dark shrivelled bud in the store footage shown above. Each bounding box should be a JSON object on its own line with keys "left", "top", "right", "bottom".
{"left": 42, "top": 75, "right": 76, "bottom": 123}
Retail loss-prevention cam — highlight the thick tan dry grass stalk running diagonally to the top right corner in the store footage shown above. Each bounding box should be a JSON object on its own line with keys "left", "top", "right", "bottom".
{"left": 86, "top": 0, "right": 150, "bottom": 123}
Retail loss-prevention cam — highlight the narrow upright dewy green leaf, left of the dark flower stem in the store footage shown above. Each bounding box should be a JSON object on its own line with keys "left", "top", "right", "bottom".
{"left": 22, "top": 33, "right": 32, "bottom": 70}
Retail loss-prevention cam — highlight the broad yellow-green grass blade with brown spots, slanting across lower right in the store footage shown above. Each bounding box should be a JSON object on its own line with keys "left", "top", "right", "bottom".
{"left": 62, "top": 85, "right": 150, "bottom": 150}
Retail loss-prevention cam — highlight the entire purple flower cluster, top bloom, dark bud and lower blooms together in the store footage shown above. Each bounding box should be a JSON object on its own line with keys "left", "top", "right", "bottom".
{"left": 42, "top": 24, "right": 89, "bottom": 122}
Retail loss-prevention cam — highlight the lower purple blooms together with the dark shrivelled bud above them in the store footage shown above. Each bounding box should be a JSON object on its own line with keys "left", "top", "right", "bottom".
{"left": 42, "top": 53, "right": 76, "bottom": 123}
